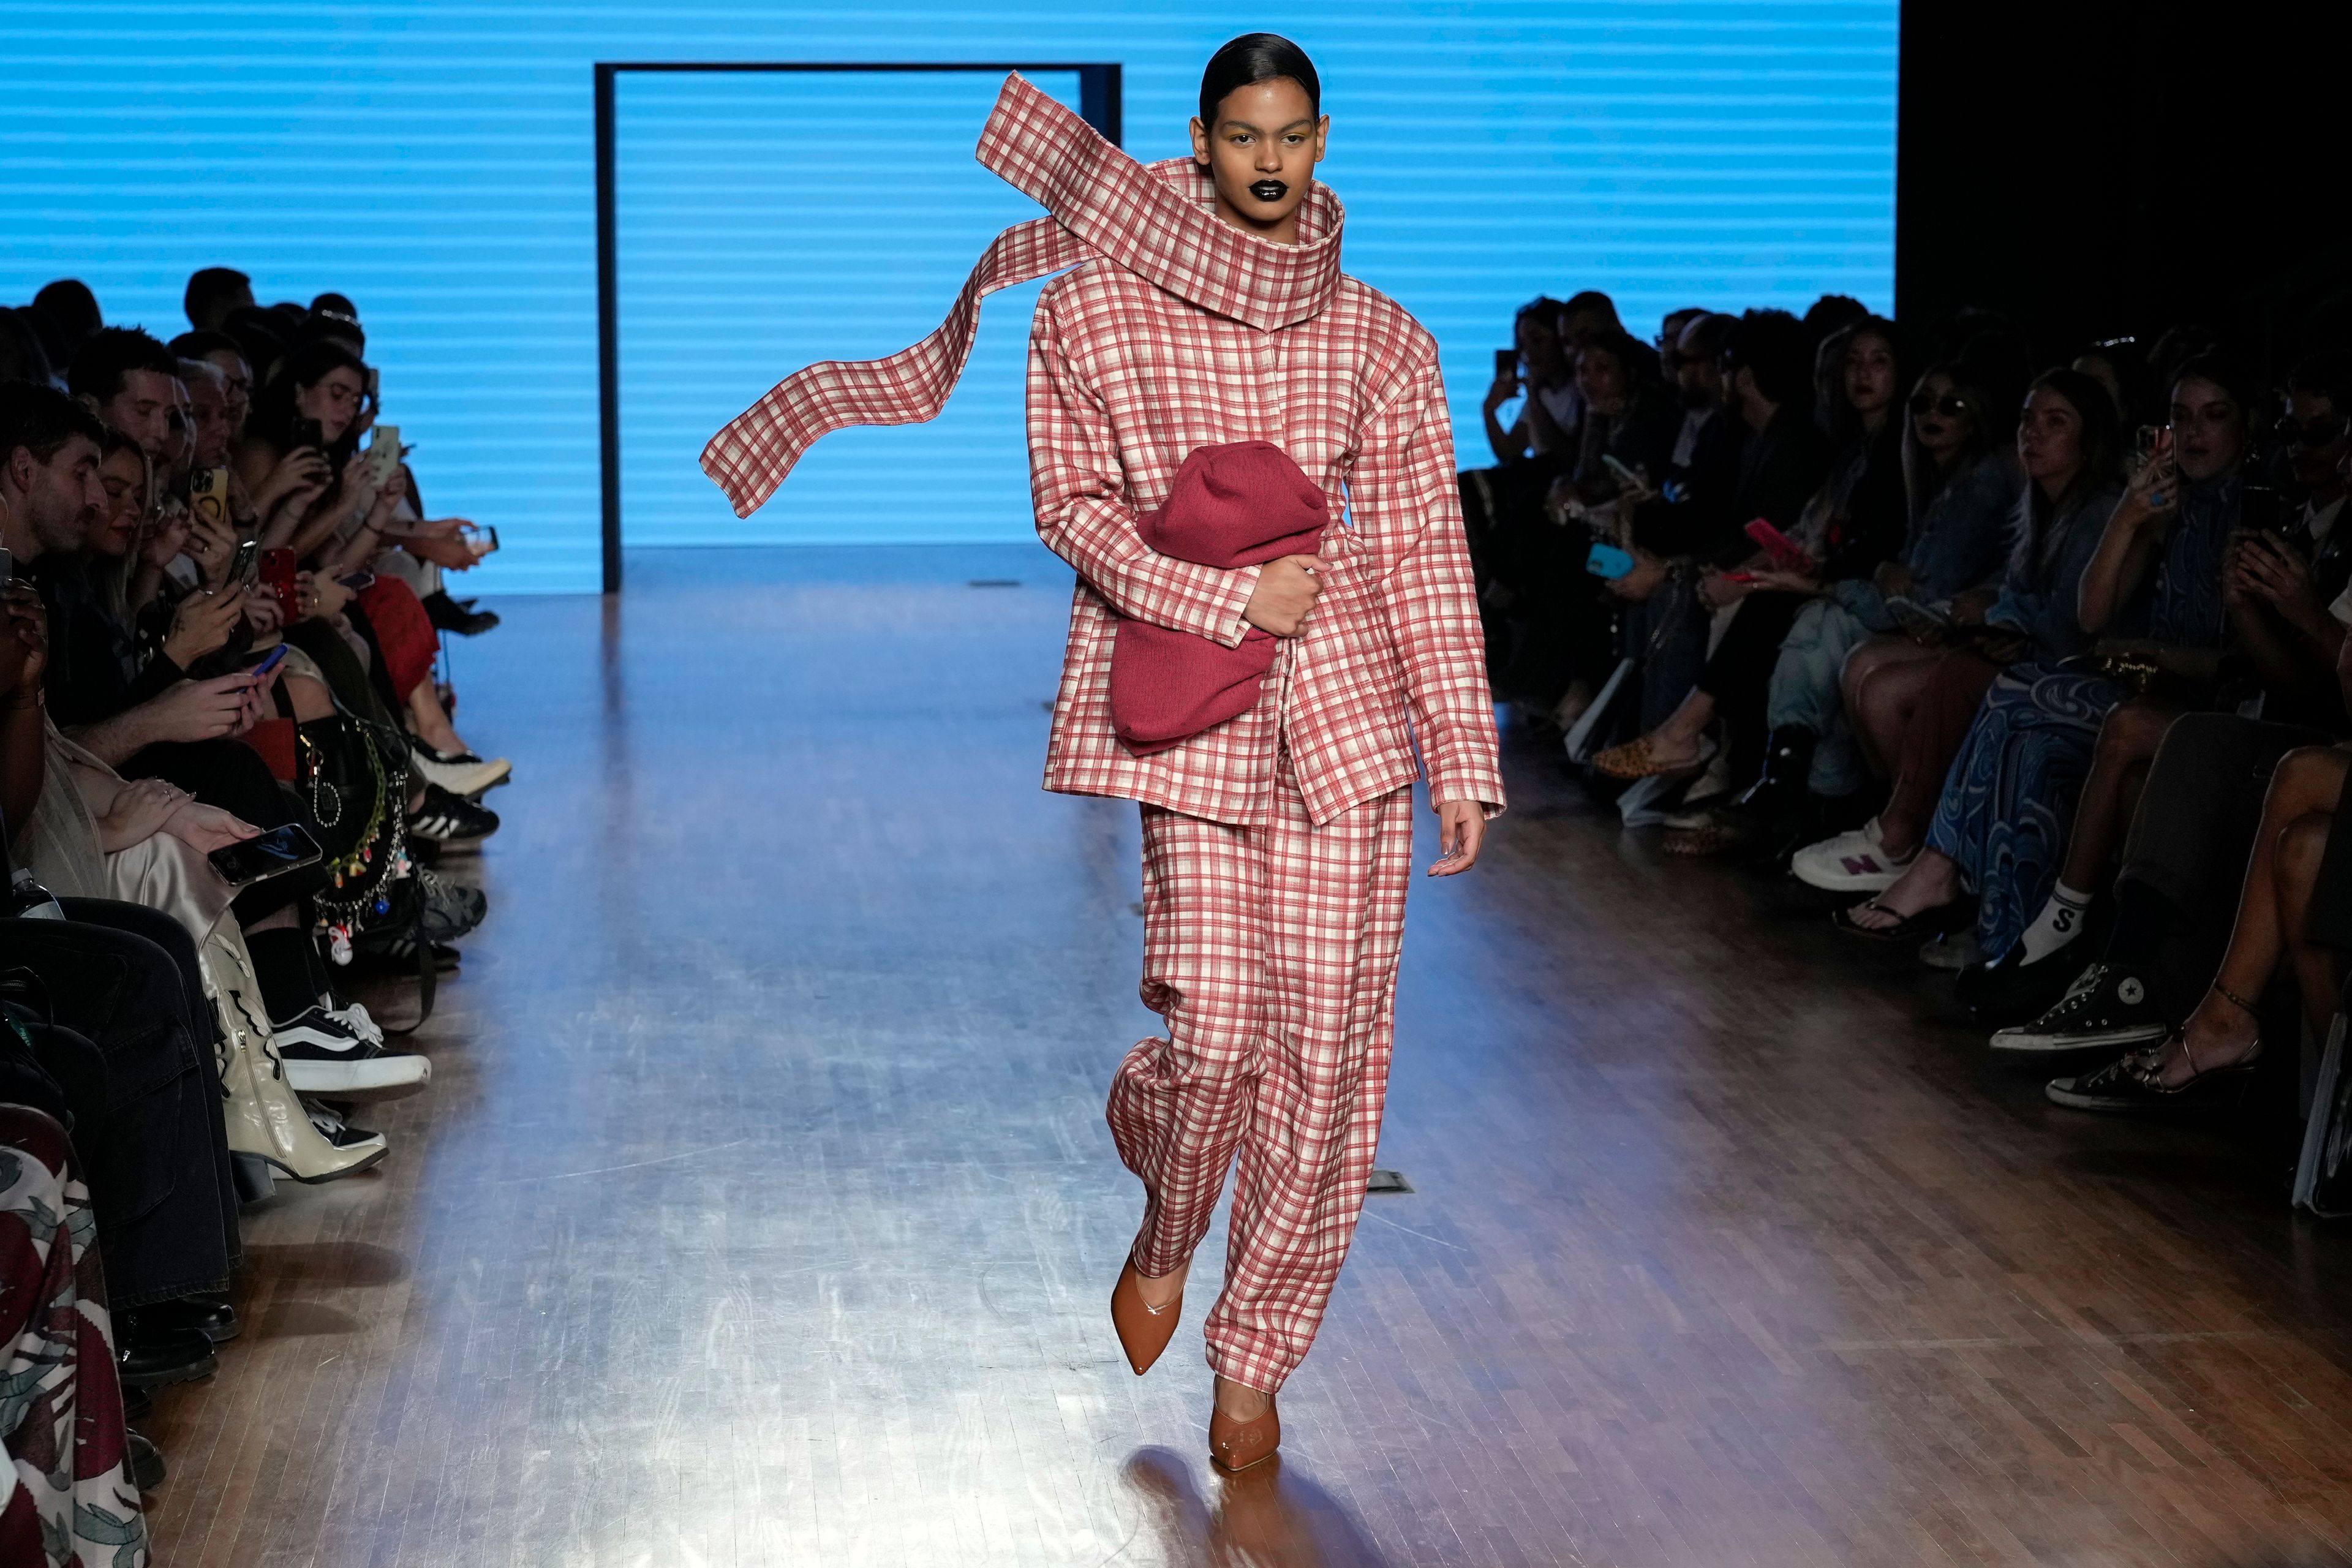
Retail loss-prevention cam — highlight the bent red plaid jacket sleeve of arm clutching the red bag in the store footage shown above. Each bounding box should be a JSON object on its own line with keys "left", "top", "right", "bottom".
{"left": 1028, "top": 292, "right": 1258, "bottom": 649}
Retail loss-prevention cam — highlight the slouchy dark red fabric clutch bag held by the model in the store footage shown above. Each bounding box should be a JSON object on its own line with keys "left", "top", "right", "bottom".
{"left": 1110, "top": 442, "right": 1329, "bottom": 757}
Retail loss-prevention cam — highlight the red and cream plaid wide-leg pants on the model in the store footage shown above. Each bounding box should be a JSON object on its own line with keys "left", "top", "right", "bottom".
{"left": 1110, "top": 757, "right": 1414, "bottom": 1392}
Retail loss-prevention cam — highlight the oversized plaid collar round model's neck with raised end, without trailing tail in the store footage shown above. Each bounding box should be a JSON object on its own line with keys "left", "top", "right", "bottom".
{"left": 978, "top": 73, "right": 1348, "bottom": 331}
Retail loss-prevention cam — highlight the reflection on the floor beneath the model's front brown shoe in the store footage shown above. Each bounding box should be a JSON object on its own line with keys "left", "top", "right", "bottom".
{"left": 1125, "top": 1448, "right": 1388, "bottom": 1568}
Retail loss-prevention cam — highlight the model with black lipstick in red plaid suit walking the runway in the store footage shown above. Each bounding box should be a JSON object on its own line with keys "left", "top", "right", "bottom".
{"left": 703, "top": 33, "right": 1503, "bottom": 1469}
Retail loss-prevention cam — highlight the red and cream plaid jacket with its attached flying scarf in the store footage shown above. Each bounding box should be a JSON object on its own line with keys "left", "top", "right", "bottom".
{"left": 703, "top": 75, "right": 1503, "bottom": 825}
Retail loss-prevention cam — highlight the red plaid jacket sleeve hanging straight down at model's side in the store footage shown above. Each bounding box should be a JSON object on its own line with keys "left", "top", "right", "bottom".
{"left": 1348, "top": 343, "right": 1503, "bottom": 816}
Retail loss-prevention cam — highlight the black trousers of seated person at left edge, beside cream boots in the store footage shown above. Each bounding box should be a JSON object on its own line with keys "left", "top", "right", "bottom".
{"left": 0, "top": 898, "right": 238, "bottom": 1307}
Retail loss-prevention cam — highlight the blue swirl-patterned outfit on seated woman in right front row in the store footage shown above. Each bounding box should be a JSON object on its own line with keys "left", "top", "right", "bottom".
{"left": 1926, "top": 470, "right": 2242, "bottom": 957}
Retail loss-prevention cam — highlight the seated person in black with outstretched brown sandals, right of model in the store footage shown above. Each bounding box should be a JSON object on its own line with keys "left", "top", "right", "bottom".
{"left": 1593, "top": 311, "right": 1834, "bottom": 780}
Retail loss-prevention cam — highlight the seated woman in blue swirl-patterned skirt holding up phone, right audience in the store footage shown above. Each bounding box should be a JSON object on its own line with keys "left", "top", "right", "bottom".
{"left": 1851, "top": 357, "right": 2251, "bottom": 966}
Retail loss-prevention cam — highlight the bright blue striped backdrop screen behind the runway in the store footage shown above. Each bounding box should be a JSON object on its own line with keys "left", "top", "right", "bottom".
{"left": 0, "top": 0, "right": 1898, "bottom": 592}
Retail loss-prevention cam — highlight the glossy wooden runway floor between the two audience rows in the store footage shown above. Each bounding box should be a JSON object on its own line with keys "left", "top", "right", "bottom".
{"left": 148, "top": 548, "right": 2352, "bottom": 1568}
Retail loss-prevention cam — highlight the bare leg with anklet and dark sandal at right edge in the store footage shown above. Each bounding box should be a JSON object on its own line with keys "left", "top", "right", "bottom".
{"left": 2150, "top": 745, "right": 2352, "bottom": 1088}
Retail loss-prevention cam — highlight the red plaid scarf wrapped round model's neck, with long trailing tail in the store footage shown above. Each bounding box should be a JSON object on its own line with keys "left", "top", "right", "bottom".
{"left": 703, "top": 73, "right": 1345, "bottom": 517}
